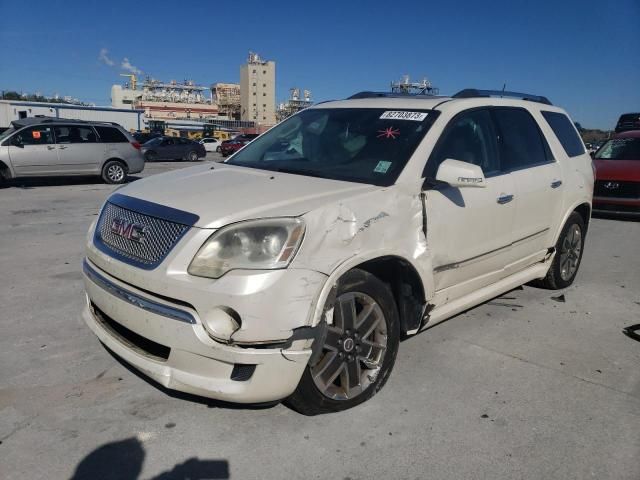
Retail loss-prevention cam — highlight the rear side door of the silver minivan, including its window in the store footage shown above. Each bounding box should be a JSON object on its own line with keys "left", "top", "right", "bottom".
{"left": 54, "top": 124, "right": 105, "bottom": 174}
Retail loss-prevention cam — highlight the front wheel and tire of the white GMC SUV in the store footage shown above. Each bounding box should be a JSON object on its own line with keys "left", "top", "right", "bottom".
{"left": 286, "top": 269, "right": 400, "bottom": 415}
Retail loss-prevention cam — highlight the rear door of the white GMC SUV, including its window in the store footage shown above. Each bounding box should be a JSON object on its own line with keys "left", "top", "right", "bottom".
{"left": 492, "top": 107, "right": 563, "bottom": 273}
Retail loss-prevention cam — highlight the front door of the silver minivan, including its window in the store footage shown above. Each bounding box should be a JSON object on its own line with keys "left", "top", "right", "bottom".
{"left": 8, "top": 125, "right": 59, "bottom": 176}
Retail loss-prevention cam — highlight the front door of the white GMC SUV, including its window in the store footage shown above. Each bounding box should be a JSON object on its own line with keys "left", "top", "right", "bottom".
{"left": 425, "top": 109, "right": 515, "bottom": 302}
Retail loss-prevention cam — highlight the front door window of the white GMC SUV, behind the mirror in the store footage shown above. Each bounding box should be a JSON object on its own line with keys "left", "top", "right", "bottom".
{"left": 425, "top": 109, "right": 500, "bottom": 178}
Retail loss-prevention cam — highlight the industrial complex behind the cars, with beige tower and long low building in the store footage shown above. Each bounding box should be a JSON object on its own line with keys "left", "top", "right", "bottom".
{"left": 0, "top": 52, "right": 278, "bottom": 135}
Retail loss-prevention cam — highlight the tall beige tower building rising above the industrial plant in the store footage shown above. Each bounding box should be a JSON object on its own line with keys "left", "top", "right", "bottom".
{"left": 240, "top": 52, "right": 276, "bottom": 126}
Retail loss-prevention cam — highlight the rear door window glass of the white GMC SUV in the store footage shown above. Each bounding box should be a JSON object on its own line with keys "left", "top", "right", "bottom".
{"left": 493, "top": 108, "right": 550, "bottom": 172}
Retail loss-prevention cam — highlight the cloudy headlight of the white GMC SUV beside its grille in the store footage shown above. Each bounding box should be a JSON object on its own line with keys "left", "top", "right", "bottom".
{"left": 188, "top": 218, "right": 304, "bottom": 278}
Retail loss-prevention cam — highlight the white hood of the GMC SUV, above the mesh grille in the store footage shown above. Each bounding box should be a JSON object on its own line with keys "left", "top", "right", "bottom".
{"left": 113, "top": 163, "right": 380, "bottom": 228}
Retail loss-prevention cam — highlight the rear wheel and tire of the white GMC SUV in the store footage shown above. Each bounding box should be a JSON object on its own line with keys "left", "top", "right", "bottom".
{"left": 537, "top": 212, "right": 586, "bottom": 290}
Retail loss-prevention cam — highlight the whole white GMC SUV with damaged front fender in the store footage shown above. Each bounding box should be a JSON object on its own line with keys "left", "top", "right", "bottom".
{"left": 84, "top": 90, "right": 593, "bottom": 414}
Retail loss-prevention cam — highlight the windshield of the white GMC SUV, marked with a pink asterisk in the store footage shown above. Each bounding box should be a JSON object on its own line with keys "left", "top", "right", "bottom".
{"left": 227, "top": 108, "right": 435, "bottom": 186}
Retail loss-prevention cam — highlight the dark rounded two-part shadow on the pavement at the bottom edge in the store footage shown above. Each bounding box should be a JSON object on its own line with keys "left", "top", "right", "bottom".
{"left": 71, "top": 437, "right": 230, "bottom": 480}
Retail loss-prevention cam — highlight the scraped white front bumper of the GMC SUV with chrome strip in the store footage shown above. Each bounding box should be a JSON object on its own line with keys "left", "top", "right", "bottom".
{"left": 83, "top": 260, "right": 312, "bottom": 403}
